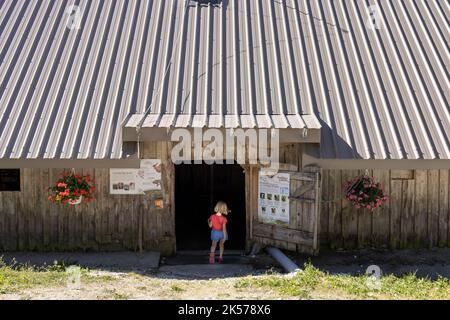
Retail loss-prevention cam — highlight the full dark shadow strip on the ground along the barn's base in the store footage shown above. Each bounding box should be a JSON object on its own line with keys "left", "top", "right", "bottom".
{"left": 0, "top": 249, "right": 450, "bottom": 280}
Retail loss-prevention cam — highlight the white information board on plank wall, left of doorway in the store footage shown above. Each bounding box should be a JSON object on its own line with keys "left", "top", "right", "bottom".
{"left": 109, "top": 159, "right": 161, "bottom": 194}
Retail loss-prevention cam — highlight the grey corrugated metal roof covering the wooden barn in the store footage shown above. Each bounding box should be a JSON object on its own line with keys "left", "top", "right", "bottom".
{"left": 0, "top": 0, "right": 450, "bottom": 159}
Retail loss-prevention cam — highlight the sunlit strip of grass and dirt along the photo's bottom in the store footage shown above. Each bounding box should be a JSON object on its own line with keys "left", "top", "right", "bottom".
{"left": 0, "top": 264, "right": 450, "bottom": 300}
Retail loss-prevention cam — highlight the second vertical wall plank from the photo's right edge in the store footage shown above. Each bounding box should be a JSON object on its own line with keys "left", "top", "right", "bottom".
{"left": 428, "top": 170, "right": 439, "bottom": 248}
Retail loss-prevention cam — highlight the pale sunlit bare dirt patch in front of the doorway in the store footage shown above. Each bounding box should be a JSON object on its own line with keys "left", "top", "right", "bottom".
{"left": 0, "top": 271, "right": 289, "bottom": 300}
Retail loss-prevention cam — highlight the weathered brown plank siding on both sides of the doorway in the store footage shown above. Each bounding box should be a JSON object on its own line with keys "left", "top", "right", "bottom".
{"left": 0, "top": 142, "right": 450, "bottom": 253}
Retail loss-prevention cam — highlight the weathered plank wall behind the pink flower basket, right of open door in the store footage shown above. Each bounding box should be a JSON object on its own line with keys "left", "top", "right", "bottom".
{"left": 320, "top": 170, "right": 450, "bottom": 249}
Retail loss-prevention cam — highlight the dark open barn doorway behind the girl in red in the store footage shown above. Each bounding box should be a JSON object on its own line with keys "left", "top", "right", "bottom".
{"left": 175, "top": 164, "right": 246, "bottom": 250}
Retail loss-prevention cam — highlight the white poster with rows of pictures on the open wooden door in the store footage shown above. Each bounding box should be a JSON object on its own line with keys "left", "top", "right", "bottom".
{"left": 258, "top": 171, "right": 290, "bottom": 226}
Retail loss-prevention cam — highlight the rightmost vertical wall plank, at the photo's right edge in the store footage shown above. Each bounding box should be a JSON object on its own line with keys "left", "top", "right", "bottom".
{"left": 438, "top": 170, "right": 450, "bottom": 247}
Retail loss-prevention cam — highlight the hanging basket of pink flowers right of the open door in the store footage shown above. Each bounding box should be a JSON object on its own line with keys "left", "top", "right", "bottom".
{"left": 344, "top": 175, "right": 389, "bottom": 211}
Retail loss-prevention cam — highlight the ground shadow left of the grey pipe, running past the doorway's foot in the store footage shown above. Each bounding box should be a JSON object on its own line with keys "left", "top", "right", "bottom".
{"left": 0, "top": 251, "right": 281, "bottom": 280}
